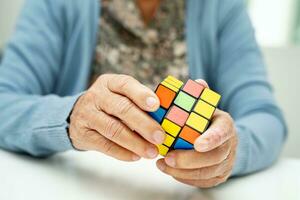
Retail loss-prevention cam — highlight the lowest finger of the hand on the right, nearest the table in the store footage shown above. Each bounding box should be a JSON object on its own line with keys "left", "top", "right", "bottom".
{"left": 173, "top": 172, "right": 230, "bottom": 188}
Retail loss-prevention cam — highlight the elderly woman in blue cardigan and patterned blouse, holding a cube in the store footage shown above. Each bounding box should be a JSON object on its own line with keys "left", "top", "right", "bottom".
{"left": 0, "top": 0, "right": 286, "bottom": 187}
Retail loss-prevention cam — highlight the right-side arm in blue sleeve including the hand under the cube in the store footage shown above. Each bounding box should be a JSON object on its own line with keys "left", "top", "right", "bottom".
{"left": 157, "top": 0, "right": 286, "bottom": 188}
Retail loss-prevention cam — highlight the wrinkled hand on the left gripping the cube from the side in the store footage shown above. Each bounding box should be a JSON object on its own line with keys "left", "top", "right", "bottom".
{"left": 69, "top": 74, "right": 165, "bottom": 161}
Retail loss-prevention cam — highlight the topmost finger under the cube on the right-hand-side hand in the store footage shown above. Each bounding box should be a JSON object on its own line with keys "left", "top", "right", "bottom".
{"left": 164, "top": 142, "right": 231, "bottom": 169}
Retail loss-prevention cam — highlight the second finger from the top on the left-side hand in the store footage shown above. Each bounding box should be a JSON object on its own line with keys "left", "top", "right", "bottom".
{"left": 97, "top": 89, "right": 165, "bottom": 144}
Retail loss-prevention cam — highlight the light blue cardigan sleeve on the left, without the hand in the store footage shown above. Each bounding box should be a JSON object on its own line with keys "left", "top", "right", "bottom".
{"left": 0, "top": 0, "right": 77, "bottom": 156}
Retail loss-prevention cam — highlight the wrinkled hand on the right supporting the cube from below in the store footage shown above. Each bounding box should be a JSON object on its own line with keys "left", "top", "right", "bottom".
{"left": 156, "top": 110, "right": 237, "bottom": 188}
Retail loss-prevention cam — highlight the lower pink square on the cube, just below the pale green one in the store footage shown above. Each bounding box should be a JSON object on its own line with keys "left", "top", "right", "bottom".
{"left": 166, "top": 105, "right": 189, "bottom": 127}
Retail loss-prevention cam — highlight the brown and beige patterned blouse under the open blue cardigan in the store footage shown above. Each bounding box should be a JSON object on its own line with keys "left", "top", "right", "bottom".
{"left": 92, "top": 0, "right": 188, "bottom": 89}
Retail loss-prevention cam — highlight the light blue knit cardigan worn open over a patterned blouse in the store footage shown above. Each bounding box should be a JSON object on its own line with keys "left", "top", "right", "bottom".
{"left": 0, "top": 0, "right": 286, "bottom": 175}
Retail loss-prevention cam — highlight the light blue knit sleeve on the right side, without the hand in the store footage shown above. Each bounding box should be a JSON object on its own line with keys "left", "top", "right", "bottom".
{"left": 213, "top": 0, "right": 286, "bottom": 175}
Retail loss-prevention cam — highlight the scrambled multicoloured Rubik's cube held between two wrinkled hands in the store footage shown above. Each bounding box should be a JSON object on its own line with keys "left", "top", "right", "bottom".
{"left": 150, "top": 76, "right": 221, "bottom": 156}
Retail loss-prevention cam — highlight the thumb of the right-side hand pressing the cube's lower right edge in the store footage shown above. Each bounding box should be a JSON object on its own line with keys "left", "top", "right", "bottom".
{"left": 194, "top": 109, "right": 234, "bottom": 152}
